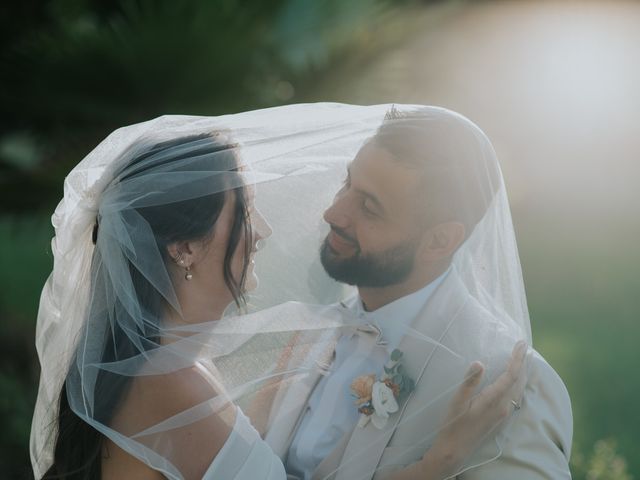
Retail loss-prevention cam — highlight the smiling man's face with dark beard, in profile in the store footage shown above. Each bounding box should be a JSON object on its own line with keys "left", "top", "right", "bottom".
{"left": 320, "top": 141, "right": 422, "bottom": 287}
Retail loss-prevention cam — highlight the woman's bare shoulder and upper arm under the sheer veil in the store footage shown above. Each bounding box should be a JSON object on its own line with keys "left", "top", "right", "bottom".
{"left": 103, "top": 364, "right": 236, "bottom": 478}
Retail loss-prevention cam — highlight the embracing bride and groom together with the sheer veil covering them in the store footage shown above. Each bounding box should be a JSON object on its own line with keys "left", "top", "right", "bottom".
{"left": 31, "top": 104, "right": 572, "bottom": 480}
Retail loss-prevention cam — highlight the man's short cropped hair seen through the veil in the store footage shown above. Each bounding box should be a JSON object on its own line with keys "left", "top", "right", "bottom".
{"left": 371, "top": 107, "right": 501, "bottom": 236}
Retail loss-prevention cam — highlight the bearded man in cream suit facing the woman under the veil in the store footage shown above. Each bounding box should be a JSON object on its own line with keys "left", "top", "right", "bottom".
{"left": 266, "top": 107, "right": 572, "bottom": 480}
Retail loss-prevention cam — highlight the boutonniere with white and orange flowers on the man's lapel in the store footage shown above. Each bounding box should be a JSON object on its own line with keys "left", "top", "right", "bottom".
{"left": 351, "top": 349, "right": 415, "bottom": 430}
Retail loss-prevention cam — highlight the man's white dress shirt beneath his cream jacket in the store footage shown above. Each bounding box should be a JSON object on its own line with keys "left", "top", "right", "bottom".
{"left": 285, "top": 272, "right": 447, "bottom": 480}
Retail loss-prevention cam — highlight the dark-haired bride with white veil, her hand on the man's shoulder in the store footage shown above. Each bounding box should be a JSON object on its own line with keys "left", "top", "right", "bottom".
{"left": 31, "top": 107, "right": 526, "bottom": 480}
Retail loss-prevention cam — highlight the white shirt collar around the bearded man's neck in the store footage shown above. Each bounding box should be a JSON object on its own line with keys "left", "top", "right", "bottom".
{"left": 352, "top": 268, "right": 451, "bottom": 352}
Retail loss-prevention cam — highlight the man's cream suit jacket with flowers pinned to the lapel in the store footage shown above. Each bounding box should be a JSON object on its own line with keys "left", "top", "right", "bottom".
{"left": 265, "top": 269, "right": 573, "bottom": 480}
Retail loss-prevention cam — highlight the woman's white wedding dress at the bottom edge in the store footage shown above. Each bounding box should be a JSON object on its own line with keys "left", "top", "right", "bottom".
{"left": 203, "top": 408, "right": 287, "bottom": 480}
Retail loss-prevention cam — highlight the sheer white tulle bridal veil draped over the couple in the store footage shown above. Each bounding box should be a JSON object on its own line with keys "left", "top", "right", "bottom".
{"left": 31, "top": 104, "right": 531, "bottom": 479}
